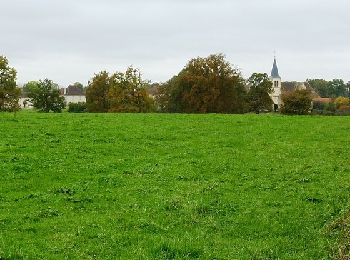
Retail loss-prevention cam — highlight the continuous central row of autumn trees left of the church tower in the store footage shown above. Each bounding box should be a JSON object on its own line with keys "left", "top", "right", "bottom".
{"left": 86, "top": 54, "right": 278, "bottom": 113}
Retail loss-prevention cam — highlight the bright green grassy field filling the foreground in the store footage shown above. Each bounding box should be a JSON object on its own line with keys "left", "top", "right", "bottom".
{"left": 0, "top": 112, "right": 350, "bottom": 259}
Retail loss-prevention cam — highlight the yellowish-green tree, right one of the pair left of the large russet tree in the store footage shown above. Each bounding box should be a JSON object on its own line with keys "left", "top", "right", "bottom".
{"left": 108, "top": 67, "right": 153, "bottom": 113}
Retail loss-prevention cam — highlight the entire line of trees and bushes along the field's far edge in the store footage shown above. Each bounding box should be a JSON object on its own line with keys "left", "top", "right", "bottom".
{"left": 0, "top": 54, "right": 349, "bottom": 114}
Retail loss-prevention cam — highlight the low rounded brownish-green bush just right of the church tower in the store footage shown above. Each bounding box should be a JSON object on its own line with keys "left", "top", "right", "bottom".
{"left": 281, "top": 89, "right": 312, "bottom": 115}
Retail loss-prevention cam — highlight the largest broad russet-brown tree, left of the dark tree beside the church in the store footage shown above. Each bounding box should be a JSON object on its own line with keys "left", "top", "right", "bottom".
{"left": 156, "top": 54, "right": 247, "bottom": 113}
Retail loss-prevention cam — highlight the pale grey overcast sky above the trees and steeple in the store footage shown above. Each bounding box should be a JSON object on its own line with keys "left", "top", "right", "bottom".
{"left": 0, "top": 0, "right": 350, "bottom": 86}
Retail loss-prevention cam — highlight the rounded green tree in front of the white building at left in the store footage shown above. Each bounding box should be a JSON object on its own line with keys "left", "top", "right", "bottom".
{"left": 25, "top": 79, "right": 65, "bottom": 113}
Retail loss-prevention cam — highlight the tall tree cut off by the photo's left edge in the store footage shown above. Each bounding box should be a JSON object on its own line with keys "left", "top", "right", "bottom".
{"left": 0, "top": 56, "right": 21, "bottom": 111}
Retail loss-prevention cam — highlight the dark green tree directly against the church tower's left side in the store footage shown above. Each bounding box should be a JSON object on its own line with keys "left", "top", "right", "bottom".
{"left": 248, "top": 73, "right": 273, "bottom": 113}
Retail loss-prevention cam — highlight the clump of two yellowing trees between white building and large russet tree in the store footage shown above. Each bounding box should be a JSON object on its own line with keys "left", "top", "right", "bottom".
{"left": 86, "top": 67, "right": 154, "bottom": 113}
